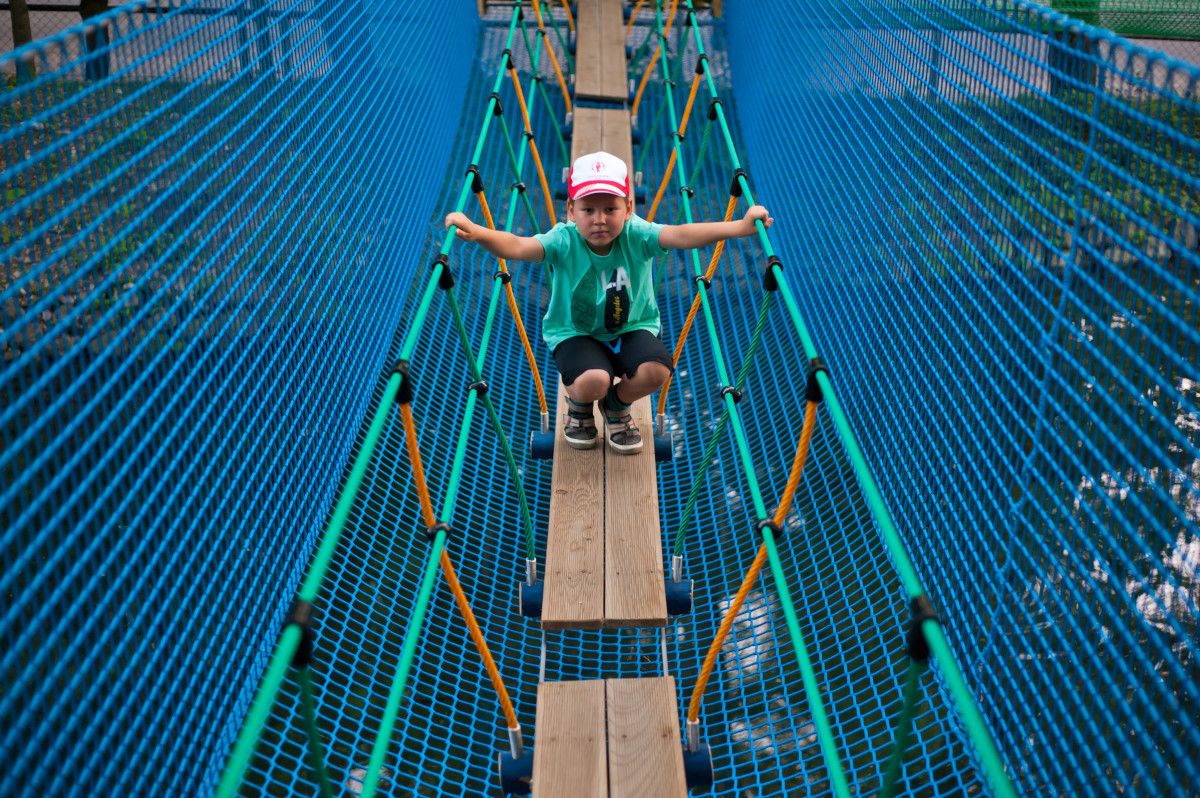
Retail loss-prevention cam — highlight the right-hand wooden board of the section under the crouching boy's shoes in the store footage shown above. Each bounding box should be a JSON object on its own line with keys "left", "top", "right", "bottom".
{"left": 604, "top": 397, "right": 667, "bottom": 628}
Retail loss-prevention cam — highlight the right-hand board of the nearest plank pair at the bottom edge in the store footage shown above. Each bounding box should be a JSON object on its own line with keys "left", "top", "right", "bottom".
{"left": 609, "top": 676, "right": 688, "bottom": 798}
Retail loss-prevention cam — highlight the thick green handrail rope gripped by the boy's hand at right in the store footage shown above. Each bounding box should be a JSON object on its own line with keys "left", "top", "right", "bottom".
{"left": 686, "top": 0, "right": 1016, "bottom": 798}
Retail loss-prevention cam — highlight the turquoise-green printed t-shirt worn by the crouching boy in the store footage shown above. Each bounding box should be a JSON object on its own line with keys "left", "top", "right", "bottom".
{"left": 534, "top": 215, "right": 666, "bottom": 352}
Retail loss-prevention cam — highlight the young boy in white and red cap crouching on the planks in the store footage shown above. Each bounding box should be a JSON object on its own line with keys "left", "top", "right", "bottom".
{"left": 445, "top": 152, "right": 774, "bottom": 455}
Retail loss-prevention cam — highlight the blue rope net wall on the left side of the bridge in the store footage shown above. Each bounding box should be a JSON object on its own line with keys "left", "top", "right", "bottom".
{"left": 0, "top": 0, "right": 478, "bottom": 794}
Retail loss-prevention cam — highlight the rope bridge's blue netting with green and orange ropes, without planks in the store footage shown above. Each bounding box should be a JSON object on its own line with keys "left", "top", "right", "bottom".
{"left": 0, "top": 1, "right": 1200, "bottom": 794}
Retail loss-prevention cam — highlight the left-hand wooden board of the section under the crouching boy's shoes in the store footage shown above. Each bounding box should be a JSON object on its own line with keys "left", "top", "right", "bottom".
{"left": 541, "top": 383, "right": 605, "bottom": 629}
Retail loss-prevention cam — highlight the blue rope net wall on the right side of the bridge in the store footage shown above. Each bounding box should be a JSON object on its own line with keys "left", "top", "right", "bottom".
{"left": 728, "top": 2, "right": 1200, "bottom": 794}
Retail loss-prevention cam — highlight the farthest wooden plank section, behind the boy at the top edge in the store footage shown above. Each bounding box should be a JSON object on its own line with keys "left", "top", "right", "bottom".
{"left": 575, "top": 0, "right": 629, "bottom": 106}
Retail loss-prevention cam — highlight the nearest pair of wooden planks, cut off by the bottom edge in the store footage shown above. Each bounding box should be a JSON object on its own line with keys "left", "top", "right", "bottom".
{"left": 533, "top": 676, "right": 688, "bottom": 798}
